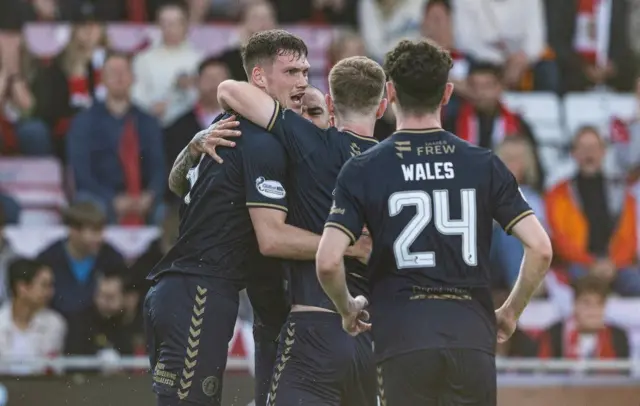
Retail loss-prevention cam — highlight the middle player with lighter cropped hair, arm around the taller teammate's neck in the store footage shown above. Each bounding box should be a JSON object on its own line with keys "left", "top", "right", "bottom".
{"left": 218, "top": 57, "right": 386, "bottom": 406}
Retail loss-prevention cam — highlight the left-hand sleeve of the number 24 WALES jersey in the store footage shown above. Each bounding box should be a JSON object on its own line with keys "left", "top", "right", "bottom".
{"left": 324, "top": 159, "right": 365, "bottom": 244}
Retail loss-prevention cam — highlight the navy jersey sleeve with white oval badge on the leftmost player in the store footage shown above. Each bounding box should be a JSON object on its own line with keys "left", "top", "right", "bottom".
{"left": 242, "top": 126, "right": 288, "bottom": 212}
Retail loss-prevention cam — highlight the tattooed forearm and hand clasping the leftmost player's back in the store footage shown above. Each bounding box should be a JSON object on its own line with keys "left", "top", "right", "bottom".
{"left": 169, "top": 116, "right": 240, "bottom": 197}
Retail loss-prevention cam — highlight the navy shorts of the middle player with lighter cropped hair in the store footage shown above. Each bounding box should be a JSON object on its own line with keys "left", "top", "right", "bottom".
{"left": 267, "top": 312, "right": 376, "bottom": 406}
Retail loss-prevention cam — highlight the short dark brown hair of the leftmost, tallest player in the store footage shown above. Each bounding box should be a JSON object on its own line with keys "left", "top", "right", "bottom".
{"left": 242, "top": 30, "right": 309, "bottom": 78}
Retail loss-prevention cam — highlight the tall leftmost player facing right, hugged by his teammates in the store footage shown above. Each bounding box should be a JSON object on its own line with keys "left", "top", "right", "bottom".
{"left": 145, "top": 30, "right": 328, "bottom": 406}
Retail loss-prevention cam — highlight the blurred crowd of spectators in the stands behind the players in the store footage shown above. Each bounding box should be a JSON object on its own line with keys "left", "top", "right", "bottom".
{"left": 0, "top": 0, "right": 640, "bottom": 374}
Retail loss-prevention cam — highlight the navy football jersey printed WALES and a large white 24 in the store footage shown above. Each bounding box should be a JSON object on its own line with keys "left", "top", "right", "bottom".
{"left": 326, "top": 129, "right": 533, "bottom": 360}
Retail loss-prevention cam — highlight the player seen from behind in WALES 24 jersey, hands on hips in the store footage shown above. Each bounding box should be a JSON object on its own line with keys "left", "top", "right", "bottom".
{"left": 316, "top": 41, "right": 551, "bottom": 406}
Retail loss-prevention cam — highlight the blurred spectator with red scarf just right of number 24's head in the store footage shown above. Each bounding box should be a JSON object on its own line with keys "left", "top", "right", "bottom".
{"left": 444, "top": 64, "right": 544, "bottom": 189}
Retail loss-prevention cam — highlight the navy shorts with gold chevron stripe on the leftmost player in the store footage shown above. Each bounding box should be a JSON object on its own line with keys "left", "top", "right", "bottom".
{"left": 144, "top": 274, "right": 238, "bottom": 406}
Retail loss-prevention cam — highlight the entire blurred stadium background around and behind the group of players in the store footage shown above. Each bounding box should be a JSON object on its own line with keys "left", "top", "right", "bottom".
{"left": 0, "top": 0, "right": 640, "bottom": 406}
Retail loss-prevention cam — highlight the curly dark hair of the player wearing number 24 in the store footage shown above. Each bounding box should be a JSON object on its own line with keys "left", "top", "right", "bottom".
{"left": 384, "top": 39, "right": 453, "bottom": 114}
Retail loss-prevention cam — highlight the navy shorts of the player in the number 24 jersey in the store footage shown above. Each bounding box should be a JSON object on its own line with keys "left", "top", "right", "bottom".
{"left": 378, "top": 349, "right": 497, "bottom": 406}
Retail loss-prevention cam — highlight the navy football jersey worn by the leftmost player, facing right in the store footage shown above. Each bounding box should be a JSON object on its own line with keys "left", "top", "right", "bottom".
{"left": 148, "top": 111, "right": 287, "bottom": 281}
